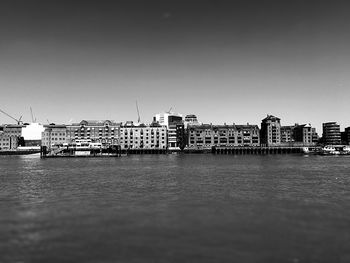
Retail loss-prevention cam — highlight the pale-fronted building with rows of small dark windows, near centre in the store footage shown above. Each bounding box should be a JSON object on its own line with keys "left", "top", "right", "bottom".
{"left": 120, "top": 122, "right": 168, "bottom": 149}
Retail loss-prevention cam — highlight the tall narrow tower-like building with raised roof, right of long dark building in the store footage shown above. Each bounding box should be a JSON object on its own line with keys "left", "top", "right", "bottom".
{"left": 260, "top": 115, "right": 281, "bottom": 146}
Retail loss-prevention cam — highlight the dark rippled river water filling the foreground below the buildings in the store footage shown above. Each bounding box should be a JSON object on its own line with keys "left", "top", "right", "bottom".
{"left": 0, "top": 155, "right": 350, "bottom": 262}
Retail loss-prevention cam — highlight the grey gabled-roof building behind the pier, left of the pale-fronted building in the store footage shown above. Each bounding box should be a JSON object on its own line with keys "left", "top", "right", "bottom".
{"left": 67, "top": 120, "right": 121, "bottom": 147}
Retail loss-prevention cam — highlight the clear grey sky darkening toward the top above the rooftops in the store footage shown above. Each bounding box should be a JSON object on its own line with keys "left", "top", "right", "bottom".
{"left": 0, "top": 0, "right": 350, "bottom": 133}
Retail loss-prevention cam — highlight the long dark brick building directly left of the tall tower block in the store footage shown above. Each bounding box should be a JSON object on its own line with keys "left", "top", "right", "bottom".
{"left": 188, "top": 124, "right": 260, "bottom": 149}
